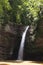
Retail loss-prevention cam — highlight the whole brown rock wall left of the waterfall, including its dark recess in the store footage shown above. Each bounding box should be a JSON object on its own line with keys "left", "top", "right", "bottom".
{"left": 0, "top": 24, "right": 25, "bottom": 60}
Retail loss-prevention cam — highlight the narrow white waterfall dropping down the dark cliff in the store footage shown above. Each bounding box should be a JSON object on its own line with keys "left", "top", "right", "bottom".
{"left": 17, "top": 26, "right": 29, "bottom": 60}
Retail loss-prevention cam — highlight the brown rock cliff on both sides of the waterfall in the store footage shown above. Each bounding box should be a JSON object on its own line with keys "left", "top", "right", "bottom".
{"left": 0, "top": 21, "right": 43, "bottom": 60}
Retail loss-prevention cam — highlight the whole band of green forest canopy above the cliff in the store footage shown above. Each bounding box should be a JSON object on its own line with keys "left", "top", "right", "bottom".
{"left": 0, "top": 0, "right": 43, "bottom": 25}
